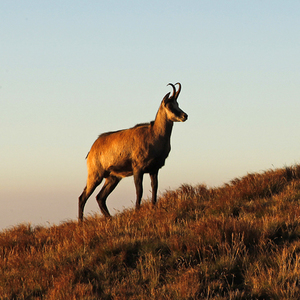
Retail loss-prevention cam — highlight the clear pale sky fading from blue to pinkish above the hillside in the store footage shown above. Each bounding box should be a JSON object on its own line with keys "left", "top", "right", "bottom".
{"left": 0, "top": 0, "right": 300, "bottom": 229}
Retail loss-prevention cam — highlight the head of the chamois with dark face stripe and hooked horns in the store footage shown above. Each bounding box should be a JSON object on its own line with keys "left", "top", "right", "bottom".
{"left": 162, "top": 82, "right": 188, "bottom": 122}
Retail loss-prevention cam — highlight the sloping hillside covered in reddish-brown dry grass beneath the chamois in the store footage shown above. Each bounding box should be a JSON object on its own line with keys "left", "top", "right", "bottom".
{"left": 0, "top": 165, "right": 300, "bottom": 300}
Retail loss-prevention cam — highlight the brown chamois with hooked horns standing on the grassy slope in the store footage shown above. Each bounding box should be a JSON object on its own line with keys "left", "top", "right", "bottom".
{"left": 79, "top": 83, "right": 188, "bottom": 221}
